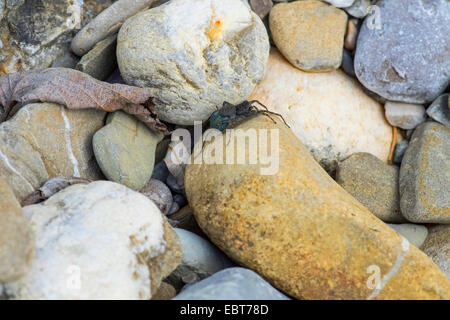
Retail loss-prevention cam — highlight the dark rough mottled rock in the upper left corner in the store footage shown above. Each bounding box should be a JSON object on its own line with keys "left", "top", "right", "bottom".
{"left": 0, "top": 0, "right": 112, "bottom": 75}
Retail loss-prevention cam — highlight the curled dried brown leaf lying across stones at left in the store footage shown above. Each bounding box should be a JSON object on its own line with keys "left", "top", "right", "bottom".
{"left": 0, "top": 68, "right": 168, "bottom": 134}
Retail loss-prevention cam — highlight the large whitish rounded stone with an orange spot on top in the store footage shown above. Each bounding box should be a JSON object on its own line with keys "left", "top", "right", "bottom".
{"left": 117, "top": 0, "right": 269, "bottom": 125}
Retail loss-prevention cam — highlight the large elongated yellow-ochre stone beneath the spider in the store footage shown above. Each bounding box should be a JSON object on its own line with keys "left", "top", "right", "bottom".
{"left": 185, "top": 115, "right": 450, "bottom": 299}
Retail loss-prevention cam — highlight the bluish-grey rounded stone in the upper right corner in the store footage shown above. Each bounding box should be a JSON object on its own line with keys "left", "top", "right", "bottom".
{"left": 355, "top": 0, "right": 450, "bottom": 104}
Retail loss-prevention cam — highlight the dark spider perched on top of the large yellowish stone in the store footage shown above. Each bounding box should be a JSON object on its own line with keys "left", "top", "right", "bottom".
{"left": 209, "top": 100, "right": 289, "bottom": 131}
